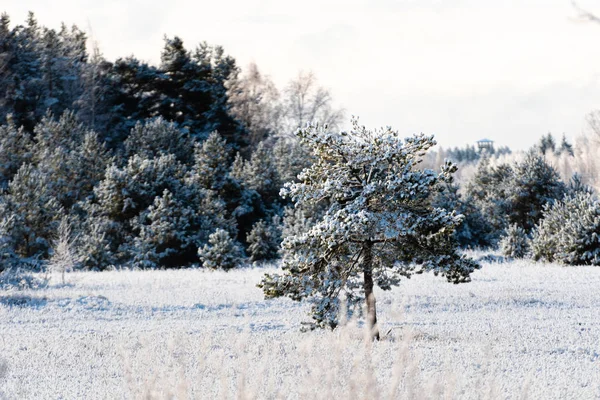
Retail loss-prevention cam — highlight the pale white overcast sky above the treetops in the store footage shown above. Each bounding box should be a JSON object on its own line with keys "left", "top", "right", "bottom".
{"left": 0, "top": 0, "right": 600, "bottom": 149}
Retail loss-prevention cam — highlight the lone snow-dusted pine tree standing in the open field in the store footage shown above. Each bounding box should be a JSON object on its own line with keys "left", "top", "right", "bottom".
{"left": 259, "top": 120, "right": 479, "bottom": 339}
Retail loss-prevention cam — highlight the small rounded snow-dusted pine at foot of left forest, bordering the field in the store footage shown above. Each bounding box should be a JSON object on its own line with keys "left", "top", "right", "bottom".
{"left": 198, "top": 228, "right": 244, "bottom": 270}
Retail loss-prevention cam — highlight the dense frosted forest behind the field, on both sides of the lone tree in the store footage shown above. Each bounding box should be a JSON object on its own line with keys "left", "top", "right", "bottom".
{"left": 0, "top": 13, "right": 600, "bottom": 276}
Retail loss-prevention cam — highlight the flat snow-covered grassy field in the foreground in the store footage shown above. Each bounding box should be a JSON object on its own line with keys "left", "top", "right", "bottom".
{"left": 0, "top": 262, "right": 600, "bottom": 399}
